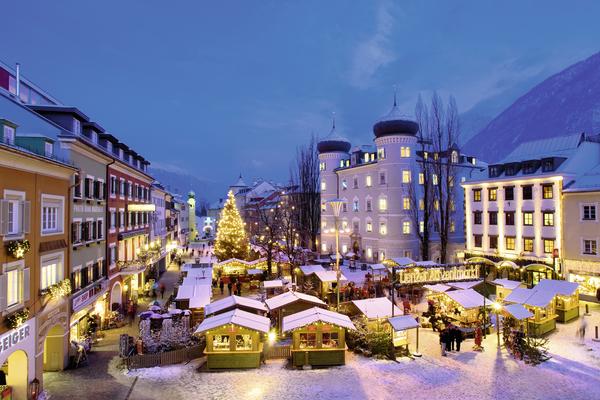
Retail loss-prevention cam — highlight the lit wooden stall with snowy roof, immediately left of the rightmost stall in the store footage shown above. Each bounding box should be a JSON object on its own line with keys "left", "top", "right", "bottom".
{"left": 504, "top": 288, "right": 557, "bottom": 337}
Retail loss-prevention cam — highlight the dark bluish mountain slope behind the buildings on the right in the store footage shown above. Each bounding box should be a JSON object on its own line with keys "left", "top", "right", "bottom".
{"left": 464, "top": 52, "right": 600, "bottom": 162}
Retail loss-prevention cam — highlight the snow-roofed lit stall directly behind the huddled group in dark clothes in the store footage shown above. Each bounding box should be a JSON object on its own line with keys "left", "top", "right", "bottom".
{"left": 440, "top": 289, "right": 492, "bottom": 328}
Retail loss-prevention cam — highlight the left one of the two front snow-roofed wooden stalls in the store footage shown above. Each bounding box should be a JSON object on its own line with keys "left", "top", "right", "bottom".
{"left": 195, "top": 309, "right": 271, "bottom": 370}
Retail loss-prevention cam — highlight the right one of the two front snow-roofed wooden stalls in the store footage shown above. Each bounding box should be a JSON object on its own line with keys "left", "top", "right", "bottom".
{"left": 283, "top": 307, "right": 356, "bottom": 367}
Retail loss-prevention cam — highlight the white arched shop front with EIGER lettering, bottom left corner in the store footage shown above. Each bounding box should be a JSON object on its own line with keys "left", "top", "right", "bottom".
{"left": 0, "top": 318, "right": 36, "bottom": 400}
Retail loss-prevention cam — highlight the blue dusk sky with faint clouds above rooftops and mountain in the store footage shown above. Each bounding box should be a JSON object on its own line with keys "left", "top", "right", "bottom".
{"left": 0, "top": 0, "right": 600, "bottom": 197}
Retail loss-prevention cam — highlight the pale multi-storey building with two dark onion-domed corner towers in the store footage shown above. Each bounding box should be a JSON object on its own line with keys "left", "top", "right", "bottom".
{"left": 317, "top": 100, "right": 482, "bottom": 262}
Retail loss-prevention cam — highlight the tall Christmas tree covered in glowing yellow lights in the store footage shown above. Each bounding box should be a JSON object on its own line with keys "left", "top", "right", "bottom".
{"left": 215, "top": 191, "right": 249, "bottom": 261}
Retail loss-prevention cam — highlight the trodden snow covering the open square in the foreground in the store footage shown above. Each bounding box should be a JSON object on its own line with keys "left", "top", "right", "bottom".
{"left": 118, "top": 316, "right": 600, "bottom": 400}
